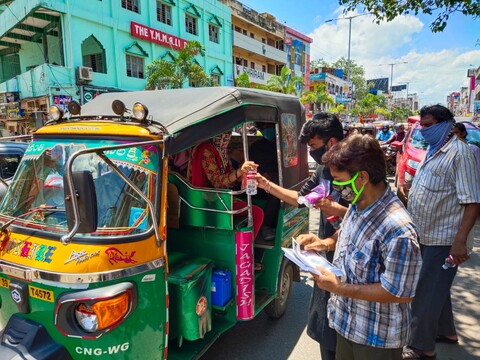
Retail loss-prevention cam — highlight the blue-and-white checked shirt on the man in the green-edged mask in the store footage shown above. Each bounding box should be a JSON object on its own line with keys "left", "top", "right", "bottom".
{"left": 328, "top": 189, "right": 422, "bottom": 349}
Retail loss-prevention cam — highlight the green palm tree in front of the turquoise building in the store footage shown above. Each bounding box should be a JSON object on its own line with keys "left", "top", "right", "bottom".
{"left": 146, "top": 41, "right": 210, "bottom": 90}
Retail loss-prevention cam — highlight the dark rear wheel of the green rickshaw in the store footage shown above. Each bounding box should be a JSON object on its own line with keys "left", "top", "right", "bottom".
{"left": 265, "top": 259, "right": 293, "bottom": 319}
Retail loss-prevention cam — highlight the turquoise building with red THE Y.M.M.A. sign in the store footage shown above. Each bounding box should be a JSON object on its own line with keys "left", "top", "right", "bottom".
{"left": 0, "top": 0, "right": 233, "bottom": 133}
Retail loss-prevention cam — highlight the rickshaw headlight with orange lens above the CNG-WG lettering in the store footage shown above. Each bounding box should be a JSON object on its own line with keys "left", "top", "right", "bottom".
{"left": 75, "top": 293, "right": 130, "bottom": 332}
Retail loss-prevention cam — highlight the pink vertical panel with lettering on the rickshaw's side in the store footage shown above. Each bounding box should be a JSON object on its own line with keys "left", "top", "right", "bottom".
{"left": 235, "top": 231, "right": 255, "bottom": 320}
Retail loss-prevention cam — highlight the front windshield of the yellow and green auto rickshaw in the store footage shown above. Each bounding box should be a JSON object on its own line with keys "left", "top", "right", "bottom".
{"left": 0, "top": 139, "right": 159, "bottom": 237}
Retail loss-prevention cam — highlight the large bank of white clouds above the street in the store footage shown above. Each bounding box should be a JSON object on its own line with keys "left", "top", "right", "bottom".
{"left": 309, "top": 9, "right": 480, "bottom": 104}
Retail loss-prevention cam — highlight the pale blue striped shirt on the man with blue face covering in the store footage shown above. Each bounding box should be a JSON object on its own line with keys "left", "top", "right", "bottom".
{"left": 408, "top": 136, "right": 480, "bottom": 247}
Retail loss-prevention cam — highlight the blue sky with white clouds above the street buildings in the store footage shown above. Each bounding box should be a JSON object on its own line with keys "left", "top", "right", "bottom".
{"left": 244, "top": 0, "right": 480, "bottom": 105}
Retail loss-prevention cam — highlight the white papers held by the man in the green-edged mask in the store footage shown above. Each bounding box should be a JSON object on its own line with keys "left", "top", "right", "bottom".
{"left": 282, "top": 238, "right": 342, "bottom": 276}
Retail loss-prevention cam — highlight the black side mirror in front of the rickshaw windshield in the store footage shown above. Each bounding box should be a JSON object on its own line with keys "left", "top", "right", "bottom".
{"left": 63, "top": 171, "right": 98, "bottom": 233}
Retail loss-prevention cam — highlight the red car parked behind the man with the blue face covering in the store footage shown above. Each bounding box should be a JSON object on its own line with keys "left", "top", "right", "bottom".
{"left": 395, "top": 115, "right": 480, "bottom": 204}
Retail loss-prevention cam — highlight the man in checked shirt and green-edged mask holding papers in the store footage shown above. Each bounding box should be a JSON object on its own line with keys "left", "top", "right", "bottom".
{"left": 301, "top": 135, "right": 422, "bottom": 360}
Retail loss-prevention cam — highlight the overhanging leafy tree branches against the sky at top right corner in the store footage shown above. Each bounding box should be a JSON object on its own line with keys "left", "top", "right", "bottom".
{"left": 338, "top": 0, "right": 480, "bottom": 32}
